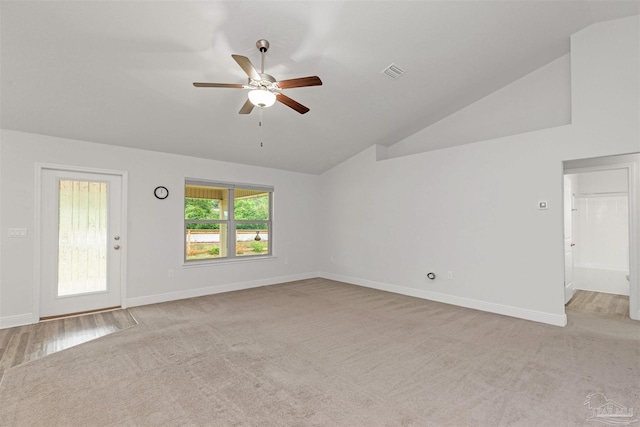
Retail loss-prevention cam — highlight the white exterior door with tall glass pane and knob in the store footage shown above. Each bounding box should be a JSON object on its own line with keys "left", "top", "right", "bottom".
{"left": 40, "top": 169, "right": 123, "bottom": 318}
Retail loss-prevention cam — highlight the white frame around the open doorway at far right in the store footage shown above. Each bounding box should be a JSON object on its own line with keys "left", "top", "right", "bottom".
{"left": 562, "top": 160, "right": 640, "bottom": 320}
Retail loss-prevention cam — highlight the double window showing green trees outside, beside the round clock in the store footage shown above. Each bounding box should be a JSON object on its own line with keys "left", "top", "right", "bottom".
{"left": 184, "top": 180, "right": 273, "bottom": 261}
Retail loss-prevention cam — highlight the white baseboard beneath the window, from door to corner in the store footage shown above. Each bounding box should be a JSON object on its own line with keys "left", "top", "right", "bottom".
{"left": 127, "top": 272, "right": 318, "bottom": 307}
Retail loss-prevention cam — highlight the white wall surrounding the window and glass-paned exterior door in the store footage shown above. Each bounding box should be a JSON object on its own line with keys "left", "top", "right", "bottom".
{"left": 0, "top": 130, "right": 320, "bottom": 327}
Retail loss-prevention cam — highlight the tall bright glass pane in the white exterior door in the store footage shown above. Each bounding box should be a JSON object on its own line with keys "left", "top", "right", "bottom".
{"left": 57, "top": 180, "right": 108, "bottom": 297}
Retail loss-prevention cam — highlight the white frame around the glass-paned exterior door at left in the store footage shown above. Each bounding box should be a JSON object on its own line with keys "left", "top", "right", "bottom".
{"left": 32, "top": 163, "right": 128, "bottom": 323}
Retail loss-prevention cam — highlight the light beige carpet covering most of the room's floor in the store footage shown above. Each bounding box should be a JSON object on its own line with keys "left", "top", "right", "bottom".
{"left": 0, "top": 279, "right": 640, "bottom": 426}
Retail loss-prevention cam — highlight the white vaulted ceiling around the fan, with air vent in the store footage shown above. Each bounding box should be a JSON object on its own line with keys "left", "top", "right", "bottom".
{"left": 0, "top": 0, "right": 640, "bottom": 173}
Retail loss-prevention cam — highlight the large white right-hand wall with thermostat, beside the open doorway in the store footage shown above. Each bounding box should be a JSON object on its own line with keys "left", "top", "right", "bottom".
{"left": 322, "top": 16, "right": 640, "bottom": 325}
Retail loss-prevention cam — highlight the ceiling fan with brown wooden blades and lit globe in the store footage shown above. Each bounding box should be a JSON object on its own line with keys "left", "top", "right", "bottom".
{"left": 193, "top": 39, "right": 322, "bottom": 114}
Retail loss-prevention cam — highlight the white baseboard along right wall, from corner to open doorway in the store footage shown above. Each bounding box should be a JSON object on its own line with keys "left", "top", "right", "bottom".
{"left": 320, "top": 272, "right": 567, "bottom": 326}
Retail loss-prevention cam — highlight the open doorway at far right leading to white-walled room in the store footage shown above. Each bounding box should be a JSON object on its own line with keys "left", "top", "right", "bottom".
{"left": 564, "top": 154, "right": 640, "bottom": 320}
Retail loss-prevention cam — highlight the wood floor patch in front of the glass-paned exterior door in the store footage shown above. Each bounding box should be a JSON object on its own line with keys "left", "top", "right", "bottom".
{"left": 0, "top": 310, "right": 137, "bottom": 378}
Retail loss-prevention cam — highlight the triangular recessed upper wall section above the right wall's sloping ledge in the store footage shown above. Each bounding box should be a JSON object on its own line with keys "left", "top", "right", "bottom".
{"left": 386, "top": 54, "right": 571, "bottom": 158}
